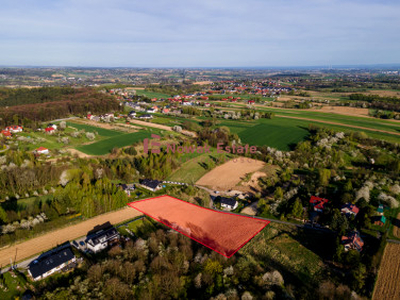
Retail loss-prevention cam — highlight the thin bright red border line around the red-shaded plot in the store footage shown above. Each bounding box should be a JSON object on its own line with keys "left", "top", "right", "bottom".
{"left": 127, "top": 195, "right": 271, "bottom": 258}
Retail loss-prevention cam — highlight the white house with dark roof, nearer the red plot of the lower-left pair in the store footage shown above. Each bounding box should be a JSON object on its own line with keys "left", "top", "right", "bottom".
{"left": 85, "top": 226, "right": 120, "bottom": 253}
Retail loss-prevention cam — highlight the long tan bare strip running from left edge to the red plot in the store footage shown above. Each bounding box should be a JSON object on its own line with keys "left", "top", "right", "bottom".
{"left": 0, "top": 207, "right": 142, "bottom": 266}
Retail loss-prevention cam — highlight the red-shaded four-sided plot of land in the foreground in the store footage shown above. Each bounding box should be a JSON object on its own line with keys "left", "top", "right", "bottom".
{"left": 128, "top": 195, "right": 269, "bottom": 258}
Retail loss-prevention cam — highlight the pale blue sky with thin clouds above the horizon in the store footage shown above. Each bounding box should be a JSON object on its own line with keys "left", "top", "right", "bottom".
{"left": 0, "top": 0, "right": 400, "bottom": 67}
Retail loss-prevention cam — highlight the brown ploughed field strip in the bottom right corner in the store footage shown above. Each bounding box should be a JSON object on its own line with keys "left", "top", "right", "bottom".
{"left": 372, "top": 243, "right": 400, "bottom": 300}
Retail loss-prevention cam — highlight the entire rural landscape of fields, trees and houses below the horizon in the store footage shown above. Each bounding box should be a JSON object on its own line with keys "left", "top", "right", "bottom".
{"left": 0, "top": 69, "right": 400, "bottom": 299}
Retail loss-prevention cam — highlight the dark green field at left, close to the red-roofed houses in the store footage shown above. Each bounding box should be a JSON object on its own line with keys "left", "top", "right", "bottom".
{"left": 76, "top": 130, "right": 151, "bottom": 155}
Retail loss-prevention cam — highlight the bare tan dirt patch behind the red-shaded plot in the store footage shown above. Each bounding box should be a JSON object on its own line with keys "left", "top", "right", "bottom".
{"left": 196, "top": 158, "right": 265, "bottom": 190}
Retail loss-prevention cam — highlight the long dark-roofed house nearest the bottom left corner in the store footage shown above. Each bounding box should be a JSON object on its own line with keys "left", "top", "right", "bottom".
{"left": 28, "top": 243, "right": 76, "bottom": 281}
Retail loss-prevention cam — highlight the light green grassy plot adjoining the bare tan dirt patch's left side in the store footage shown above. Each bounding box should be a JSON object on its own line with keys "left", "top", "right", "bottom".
{"left": 167, "top": 148, "right": 233, "bottom": 183}
